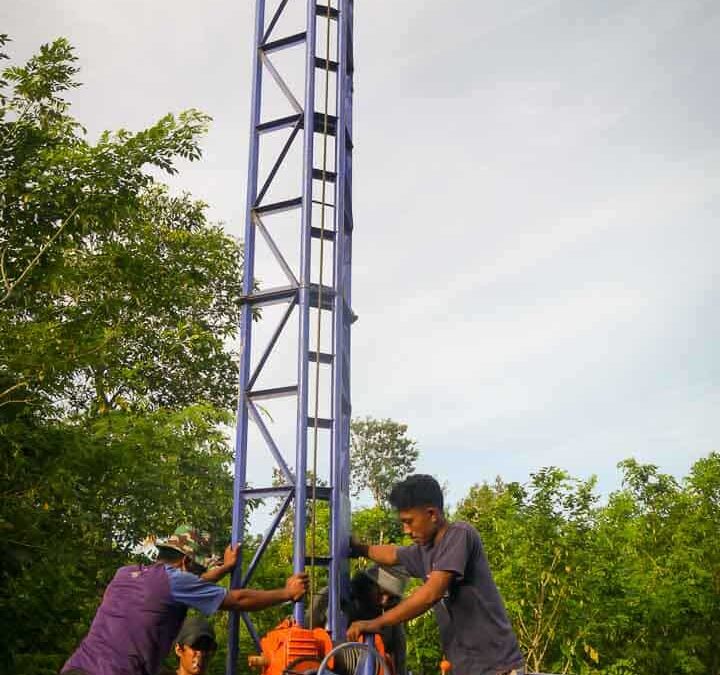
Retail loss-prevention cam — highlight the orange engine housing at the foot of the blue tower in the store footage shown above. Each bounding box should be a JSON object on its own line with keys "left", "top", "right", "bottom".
{"left": 248, "top": 619, "right": 333, "bottom": 675}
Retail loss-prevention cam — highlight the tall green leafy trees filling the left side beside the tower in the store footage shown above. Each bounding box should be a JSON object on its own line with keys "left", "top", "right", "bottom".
{"left": 0, "top": 36, "right": 242, "bottom": 673}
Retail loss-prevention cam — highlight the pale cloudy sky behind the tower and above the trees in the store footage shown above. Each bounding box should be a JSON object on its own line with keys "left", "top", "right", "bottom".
{"left": 0, "top": 0, "right": 720, "bottom": 510}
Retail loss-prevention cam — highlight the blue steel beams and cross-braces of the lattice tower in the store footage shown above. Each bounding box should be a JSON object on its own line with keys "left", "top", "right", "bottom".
{"left": 227, "top": 0, "right": 354, "bottom": 675}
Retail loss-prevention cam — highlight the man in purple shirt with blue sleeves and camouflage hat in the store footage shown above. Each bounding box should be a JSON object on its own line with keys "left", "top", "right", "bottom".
{"left": 61, "top": 525, "right": 307, "bottom": 675}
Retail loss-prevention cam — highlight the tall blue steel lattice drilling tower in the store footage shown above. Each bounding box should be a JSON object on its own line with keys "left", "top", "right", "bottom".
{"left": 227, "top": 0, "right": 354, "bottom": 674}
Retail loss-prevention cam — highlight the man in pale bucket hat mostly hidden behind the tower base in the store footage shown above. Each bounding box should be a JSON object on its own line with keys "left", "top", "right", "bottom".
{"left": 306, "top": 565, "right": 408, "bottom": 675}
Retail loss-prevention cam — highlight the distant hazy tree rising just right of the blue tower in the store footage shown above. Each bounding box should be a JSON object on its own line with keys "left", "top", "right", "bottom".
{"left": 350, "top": 417, "right": 419, "bottom": 506}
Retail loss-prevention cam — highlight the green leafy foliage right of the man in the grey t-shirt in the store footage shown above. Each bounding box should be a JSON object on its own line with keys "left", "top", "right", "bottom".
{"left": 455, "top": 453, "right": 720, "bottom": 675}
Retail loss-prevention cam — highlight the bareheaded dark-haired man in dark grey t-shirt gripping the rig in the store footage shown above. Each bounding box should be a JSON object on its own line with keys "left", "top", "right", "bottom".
{"left": 347, "top": 474, "right": 525, "bottom": 675}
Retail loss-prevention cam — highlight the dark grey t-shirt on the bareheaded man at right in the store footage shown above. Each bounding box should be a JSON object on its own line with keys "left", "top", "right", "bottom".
{"left": 397, "top": 523, "right": 522, "bottom": 675}
